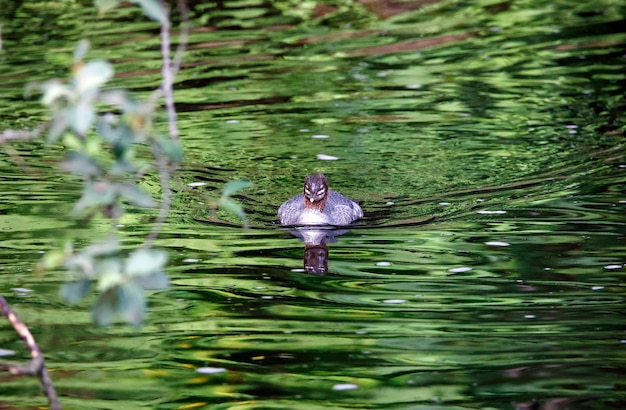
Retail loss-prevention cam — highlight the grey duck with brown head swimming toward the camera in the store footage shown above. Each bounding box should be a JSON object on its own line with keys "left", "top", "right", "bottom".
{"left": 278, "top": 173, "right": 363, "bottom": 226}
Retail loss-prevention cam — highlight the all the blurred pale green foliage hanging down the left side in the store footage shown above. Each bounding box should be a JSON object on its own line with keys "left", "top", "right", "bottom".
{"left": 25, "top": 0, "right": 177, "bottom": 326}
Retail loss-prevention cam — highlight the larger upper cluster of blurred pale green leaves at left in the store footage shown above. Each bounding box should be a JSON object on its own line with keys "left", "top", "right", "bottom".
{"left": 40, "top": 42, "right": 182, "bottom": 218}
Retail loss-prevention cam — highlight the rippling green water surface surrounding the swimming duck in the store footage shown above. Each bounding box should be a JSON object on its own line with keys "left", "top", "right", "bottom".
{"left": 0, "top": 0, "right": 626, "bottom": 410}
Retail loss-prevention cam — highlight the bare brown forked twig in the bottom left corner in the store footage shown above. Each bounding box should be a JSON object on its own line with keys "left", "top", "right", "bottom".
{"left": 0, "top": 295, "right": 61, "bottom": 410}
